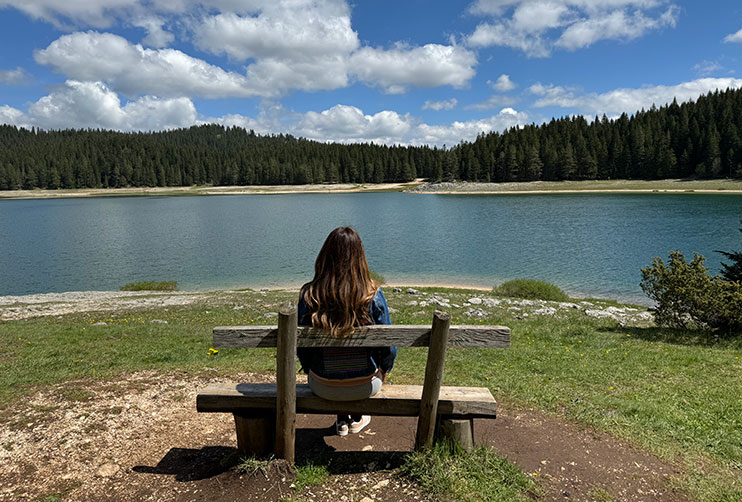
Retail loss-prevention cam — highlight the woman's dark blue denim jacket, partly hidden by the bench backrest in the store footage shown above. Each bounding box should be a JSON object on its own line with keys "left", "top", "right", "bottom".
{"left": 296, "top": 288, "right": 397, "bottom": 380}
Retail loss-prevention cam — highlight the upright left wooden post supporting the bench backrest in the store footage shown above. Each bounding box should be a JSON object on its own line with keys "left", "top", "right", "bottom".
{"left": 276, "top": 302, "right": 297, "bottom": 464}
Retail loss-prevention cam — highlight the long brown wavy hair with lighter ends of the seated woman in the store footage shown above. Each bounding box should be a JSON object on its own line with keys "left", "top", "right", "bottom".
{"left": 300, "top": 227, "right": 379, "bottom": 337}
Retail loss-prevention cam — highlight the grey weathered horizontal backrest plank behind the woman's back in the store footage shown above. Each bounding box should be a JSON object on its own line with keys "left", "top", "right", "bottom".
{"left": 213, "top": 324, "right": 510, "bottom": 349}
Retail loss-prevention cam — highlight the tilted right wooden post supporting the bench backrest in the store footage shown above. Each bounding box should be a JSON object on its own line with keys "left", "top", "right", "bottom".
{"left": 415, "top": 311, "right": 451, "bottom": 450}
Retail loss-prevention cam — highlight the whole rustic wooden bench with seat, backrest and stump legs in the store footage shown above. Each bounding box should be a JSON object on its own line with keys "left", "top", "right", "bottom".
{"left": 196, "top": 303, "right": 510, "bottom": 462}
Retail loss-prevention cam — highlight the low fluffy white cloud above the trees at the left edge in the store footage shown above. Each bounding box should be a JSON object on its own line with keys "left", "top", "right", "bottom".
{"left": 0, "top": 80, "right": 196, "bottom": 131}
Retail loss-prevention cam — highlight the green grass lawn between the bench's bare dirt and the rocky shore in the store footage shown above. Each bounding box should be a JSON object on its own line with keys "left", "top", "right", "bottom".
{"left": 0, "top": 288, "right": 742, "bottom": 501}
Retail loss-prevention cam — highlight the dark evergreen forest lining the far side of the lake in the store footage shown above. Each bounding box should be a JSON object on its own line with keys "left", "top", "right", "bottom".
{"left": 0, "top": 86, "right": 742, "bottom": 190}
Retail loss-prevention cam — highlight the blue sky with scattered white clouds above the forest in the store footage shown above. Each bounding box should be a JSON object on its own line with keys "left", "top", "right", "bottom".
{"left": 0, "top": 0, "right": 742, "bottom": 146}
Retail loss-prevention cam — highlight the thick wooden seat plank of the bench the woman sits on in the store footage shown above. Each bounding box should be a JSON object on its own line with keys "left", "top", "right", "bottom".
{"left": 196, "top": 383, "right": 497, "bottom": 419}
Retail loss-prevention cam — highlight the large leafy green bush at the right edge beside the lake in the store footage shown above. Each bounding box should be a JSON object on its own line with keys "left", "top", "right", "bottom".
{"left": 641, "top": 251, "right": 742, "bottom": 333}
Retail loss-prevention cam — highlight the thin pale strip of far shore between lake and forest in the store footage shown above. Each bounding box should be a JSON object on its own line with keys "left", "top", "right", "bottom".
{"left": 0, "top": 178, "right": 742, "bottom": 200}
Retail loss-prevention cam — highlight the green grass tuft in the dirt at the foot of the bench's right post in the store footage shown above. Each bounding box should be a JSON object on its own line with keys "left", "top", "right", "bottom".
{"left": 400, "top": 444, "right": 540, "bottom": 502}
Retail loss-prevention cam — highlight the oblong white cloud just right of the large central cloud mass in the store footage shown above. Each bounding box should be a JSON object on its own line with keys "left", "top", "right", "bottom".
{"left": 350, "top": 44, "right": 477, "bottom": 94}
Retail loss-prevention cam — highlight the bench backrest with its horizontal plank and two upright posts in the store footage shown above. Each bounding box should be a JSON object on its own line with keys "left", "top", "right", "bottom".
{"left": 214, "top": 303, "right": 510, "bottom": 463}
